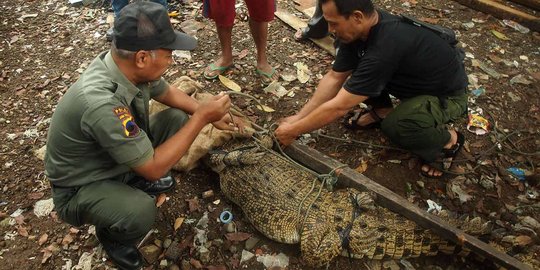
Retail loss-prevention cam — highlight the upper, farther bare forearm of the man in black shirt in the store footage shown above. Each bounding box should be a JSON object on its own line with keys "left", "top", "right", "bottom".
{"left": 284, "top": 70, "right": 352, "bottom": 123}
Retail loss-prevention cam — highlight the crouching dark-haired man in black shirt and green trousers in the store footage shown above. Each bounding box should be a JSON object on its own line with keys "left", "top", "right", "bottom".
{"left": 275, "top": 0, "right": 467, "bottom": 177}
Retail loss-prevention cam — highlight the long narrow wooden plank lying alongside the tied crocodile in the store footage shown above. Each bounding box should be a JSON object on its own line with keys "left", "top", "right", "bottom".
{"left": 285, "top": 142, "right": 532, "bottom": 269}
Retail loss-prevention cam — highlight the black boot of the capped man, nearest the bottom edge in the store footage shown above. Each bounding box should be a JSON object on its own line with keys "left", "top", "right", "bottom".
{"left": 96, "top": 230, "right": 143, "bottom": 270}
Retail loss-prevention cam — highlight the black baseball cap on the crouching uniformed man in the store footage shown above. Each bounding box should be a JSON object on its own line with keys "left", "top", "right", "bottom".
{"left": 113, "top": 1, "right": 197, "bottom": 51}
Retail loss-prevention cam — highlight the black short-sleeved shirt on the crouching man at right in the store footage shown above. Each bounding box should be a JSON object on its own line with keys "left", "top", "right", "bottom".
{"left": 333, "top": 10, "right": 467, "bottom": 98}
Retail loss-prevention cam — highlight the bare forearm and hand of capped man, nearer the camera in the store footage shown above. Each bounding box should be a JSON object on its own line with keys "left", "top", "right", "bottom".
{"left": 133, "top": 94, "right": 231, "bottom": 180}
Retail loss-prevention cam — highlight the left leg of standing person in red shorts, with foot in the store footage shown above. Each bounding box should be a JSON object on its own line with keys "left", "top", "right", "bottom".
{"left": 203, "top": 0, "right": 236, "bottom": 79}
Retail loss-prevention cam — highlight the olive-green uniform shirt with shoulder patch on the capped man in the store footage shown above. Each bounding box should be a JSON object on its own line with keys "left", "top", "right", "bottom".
{"left": 45, "top": 52, "right": 169, "bottom": 187}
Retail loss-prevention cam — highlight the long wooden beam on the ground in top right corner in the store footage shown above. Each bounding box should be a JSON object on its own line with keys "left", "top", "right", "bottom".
{"left": 454, "top": 0, "right": 540, "bottom": 32}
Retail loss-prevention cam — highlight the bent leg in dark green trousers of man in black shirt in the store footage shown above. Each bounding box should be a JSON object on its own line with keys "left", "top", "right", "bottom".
{"left": 381, "top": 94, "right": 467, "bottom": 176}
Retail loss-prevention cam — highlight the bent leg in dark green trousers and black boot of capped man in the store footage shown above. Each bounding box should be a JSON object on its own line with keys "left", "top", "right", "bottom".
{"left": 53, "top": 180, "right": 157, "bottom": 269}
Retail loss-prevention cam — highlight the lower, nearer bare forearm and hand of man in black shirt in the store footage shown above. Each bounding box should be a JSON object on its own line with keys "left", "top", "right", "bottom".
{"left": 275, "top": 88, "right": 368, "bottom": 146}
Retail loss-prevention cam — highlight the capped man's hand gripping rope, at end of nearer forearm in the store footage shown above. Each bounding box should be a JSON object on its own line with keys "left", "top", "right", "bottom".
{"left": 193, "top": 94, "right": 231, "bottom": 123}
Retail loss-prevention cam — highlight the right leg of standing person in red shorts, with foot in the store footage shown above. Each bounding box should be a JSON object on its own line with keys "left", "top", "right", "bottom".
{"left": 245, "top": 0, "right": 279, "bottom": 81}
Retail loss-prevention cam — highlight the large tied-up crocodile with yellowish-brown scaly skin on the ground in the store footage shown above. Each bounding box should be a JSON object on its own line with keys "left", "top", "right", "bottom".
{"left": 205, "top": 135, "right": 486, "bottom": 267}
